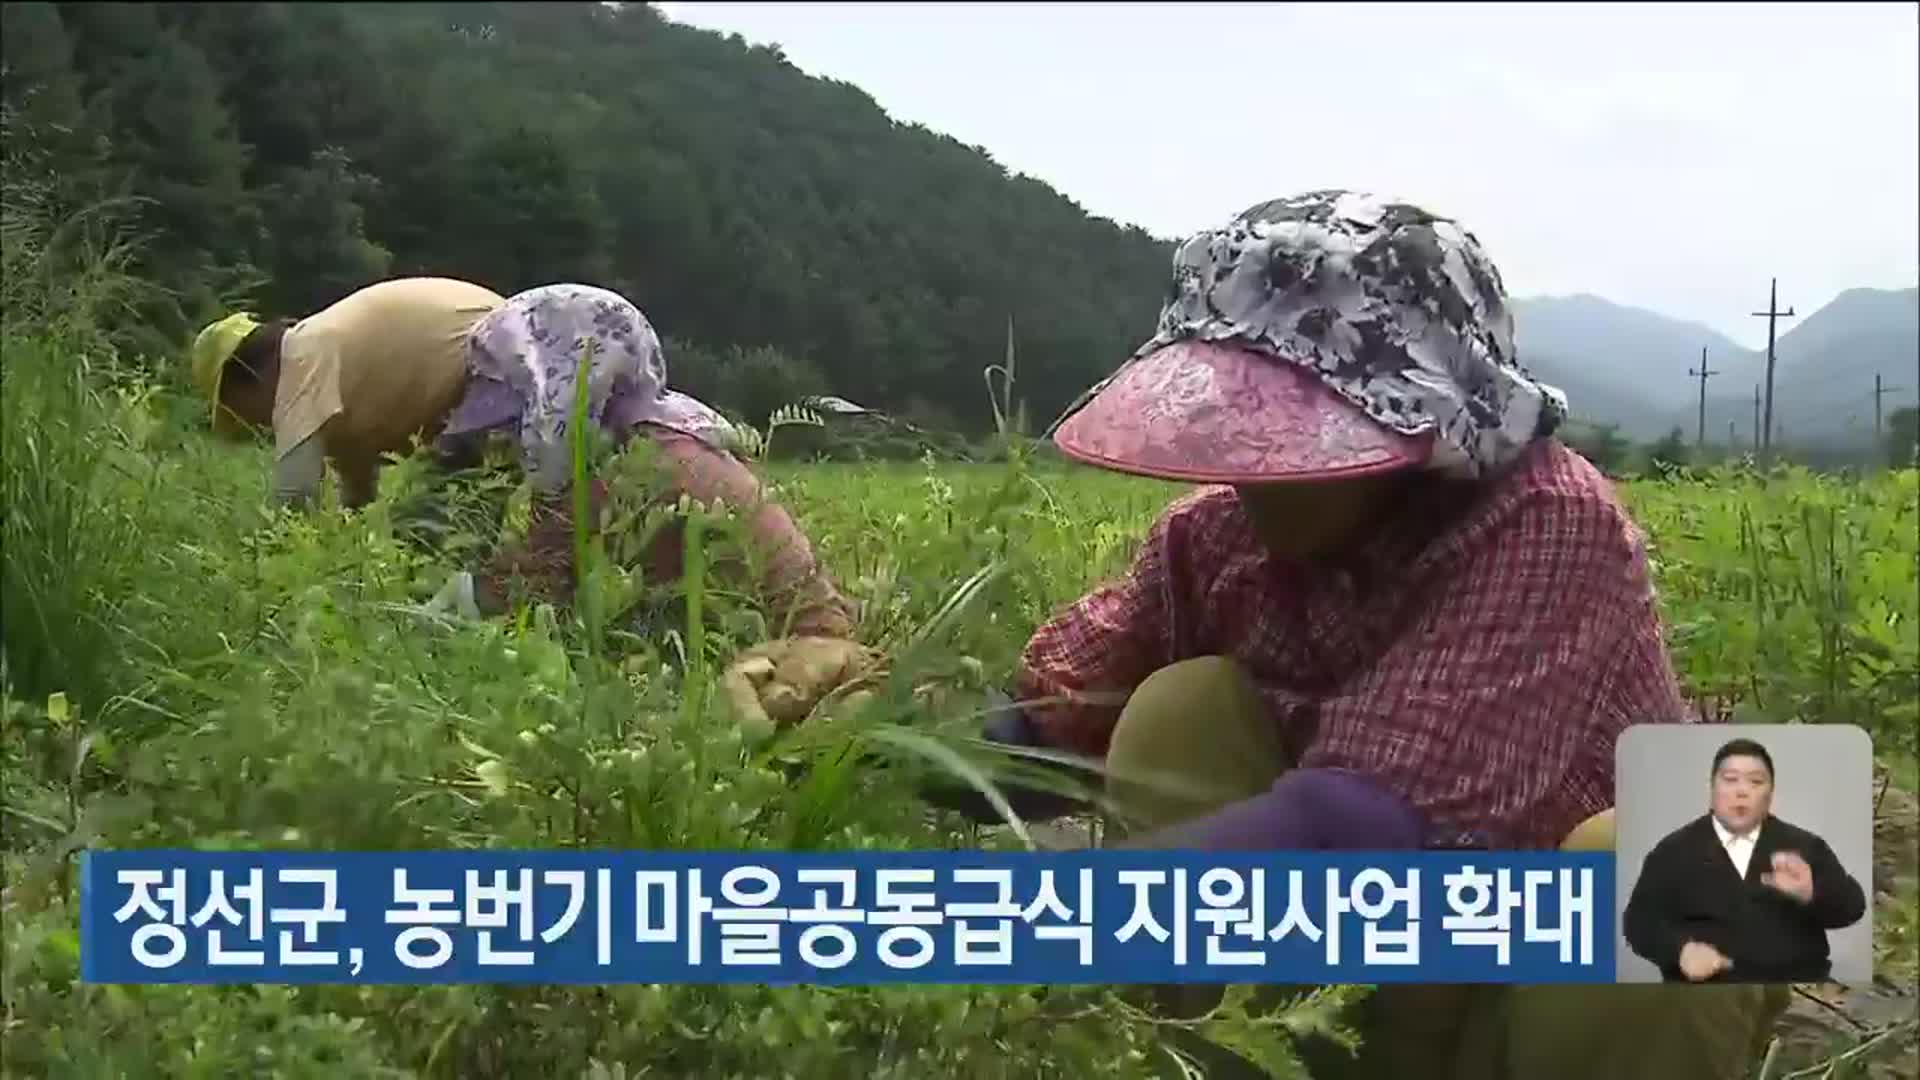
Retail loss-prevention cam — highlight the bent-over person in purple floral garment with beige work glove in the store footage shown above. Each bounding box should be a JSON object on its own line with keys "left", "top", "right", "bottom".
{"left": 434, "top": 284, "right": 864, "bottom": 721}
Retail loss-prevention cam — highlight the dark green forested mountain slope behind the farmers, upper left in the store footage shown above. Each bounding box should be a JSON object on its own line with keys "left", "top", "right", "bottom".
{"left": 0, "top": 4, "right": 1171, "bottom": 430}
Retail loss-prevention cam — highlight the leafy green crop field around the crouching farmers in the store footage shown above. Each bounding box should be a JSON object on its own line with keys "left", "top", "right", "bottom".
{"left": 0, "top": 315, "right": 1920, "bottom": 1076}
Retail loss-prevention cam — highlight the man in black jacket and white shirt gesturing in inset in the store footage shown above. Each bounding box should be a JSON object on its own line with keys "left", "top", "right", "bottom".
{"left": 1620, "top": 738, "right": 1866, "bottom": 982}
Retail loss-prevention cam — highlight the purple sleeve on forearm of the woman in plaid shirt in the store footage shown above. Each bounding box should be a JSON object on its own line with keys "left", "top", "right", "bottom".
{"left": 1125, "top": 769, "right": 1427, "bottom": 851}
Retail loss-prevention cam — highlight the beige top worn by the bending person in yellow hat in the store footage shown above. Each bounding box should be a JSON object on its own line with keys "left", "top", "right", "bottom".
{"left": 273, "top": 277, "right": 507, "bottom": 505}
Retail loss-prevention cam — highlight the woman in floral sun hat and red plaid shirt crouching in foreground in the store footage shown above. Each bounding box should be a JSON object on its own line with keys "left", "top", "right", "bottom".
{"left": 933, "top": 190, "right": 1786, "bottom": 1080}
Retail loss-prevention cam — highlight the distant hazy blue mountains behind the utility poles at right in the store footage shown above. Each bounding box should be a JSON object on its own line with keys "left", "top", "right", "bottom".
{"left": 1513, "top": 288, "right": 1920, "bottom": 446}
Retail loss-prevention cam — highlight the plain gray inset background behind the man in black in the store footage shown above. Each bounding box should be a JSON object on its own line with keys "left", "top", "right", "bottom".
{"left": 1613, "top": 724, "right": 1874, "bottom": 986}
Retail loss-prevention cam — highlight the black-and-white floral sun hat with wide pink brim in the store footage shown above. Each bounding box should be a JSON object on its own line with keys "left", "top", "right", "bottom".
{"left": 1052, "top": 190, "right": 1567, "bottom": 484}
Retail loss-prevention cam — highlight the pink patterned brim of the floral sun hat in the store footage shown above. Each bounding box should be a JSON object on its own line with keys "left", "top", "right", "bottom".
{"left": 1054, "top": 342, "right": 1432, "bottom": 484}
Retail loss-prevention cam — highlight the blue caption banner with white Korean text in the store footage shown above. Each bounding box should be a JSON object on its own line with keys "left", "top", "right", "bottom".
{"left": 81, "top": 849, "right": 1615, "bottom": 986}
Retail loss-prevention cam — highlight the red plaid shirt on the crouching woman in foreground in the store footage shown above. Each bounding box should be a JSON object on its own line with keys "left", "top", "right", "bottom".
{"left": 1018, "top": 440, "right": 1690, "bottom": 847}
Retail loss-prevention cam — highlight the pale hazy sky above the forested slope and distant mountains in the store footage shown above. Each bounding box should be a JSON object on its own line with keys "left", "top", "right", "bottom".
{"left": 659, "top": 4, "right": 1920, "bottom": 346}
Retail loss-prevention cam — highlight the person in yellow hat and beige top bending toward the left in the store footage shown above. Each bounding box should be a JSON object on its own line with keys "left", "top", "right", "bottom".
{"left": 192, "top": 277, "right": 505, "bottom": 509}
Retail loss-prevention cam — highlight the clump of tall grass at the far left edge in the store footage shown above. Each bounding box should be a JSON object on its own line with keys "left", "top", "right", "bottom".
{"left": 0, "top": 109, "right": 167, "bottom": 705}
